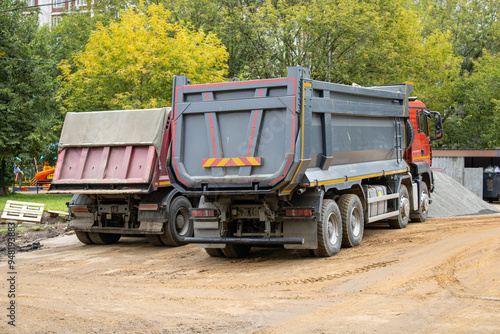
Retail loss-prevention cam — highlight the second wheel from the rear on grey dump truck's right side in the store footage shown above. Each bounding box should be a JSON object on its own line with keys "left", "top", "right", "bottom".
{"left": 338, "top": 194, "right": 365, "bottom": 247}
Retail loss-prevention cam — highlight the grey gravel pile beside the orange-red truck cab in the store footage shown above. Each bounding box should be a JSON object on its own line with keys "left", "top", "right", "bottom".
{"left": 429, "top": 172, "right": 500, "bottom": 218}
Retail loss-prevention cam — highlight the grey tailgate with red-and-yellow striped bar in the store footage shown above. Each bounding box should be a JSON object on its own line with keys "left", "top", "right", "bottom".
{"left": 169, "top": 70, "right": 300, "bottom": 191}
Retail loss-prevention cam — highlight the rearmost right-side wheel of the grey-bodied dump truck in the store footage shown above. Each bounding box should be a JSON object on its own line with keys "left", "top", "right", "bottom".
{"left": 314, "top": 199, "right": 342, "bottom": 257}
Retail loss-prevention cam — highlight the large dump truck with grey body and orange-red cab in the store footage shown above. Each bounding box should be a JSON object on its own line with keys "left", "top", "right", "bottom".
{"left": 167, "top": 67, "right": 442, "bottom": 257}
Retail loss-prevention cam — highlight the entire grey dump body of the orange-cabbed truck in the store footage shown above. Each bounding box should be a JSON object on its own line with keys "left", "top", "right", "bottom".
{"left": 170, "top": 67, "right": 413, "bottom": 195}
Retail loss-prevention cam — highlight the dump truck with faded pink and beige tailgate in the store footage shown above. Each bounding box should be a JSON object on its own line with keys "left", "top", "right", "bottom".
{"left": 49, "top": 108, "right": 196, "bottom": 246}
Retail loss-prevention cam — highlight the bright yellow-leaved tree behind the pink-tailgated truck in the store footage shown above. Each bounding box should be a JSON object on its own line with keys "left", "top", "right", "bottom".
{"left": 60, "top": 5, "right": 228, "bottom": 111}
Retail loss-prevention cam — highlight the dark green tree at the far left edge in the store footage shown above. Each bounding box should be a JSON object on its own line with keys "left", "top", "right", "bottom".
{"left": 0, "top": 0, "right": 59, "bottom": 194}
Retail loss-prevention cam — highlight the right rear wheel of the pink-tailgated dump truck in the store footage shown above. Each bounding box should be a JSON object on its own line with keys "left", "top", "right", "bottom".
{"left": 160, "top": 196, "right": 194, "bottom": 247}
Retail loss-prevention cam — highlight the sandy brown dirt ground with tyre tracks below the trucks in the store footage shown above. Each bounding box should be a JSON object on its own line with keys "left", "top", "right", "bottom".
{"left": 0, "top": 214, "right": 500, "bottom": 333}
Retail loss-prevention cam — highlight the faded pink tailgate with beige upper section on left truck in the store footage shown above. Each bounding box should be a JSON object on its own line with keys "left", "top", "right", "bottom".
{"left": 50, "top": 108, "right": 168, "bottom": 193}
